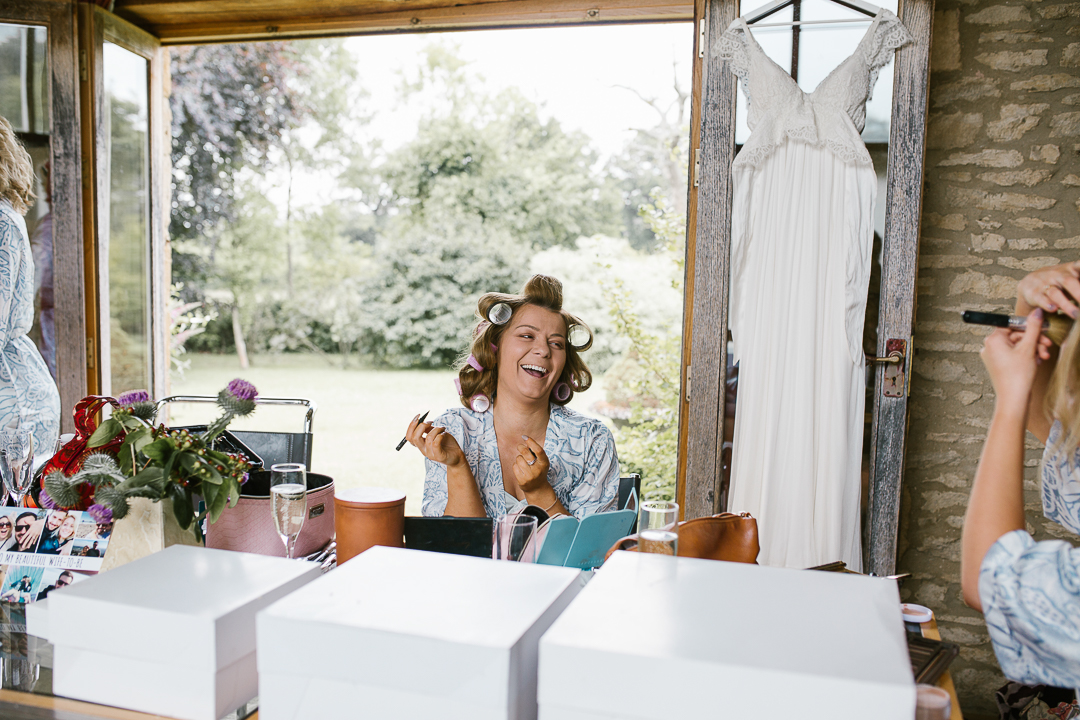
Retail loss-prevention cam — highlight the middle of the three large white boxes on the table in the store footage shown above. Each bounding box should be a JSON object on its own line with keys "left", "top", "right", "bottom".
{"left": 257, "top": 546, "right": 584, "bottom": 720}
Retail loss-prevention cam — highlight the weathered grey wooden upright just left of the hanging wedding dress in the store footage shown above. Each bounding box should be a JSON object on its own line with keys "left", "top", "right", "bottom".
{"left": 683, "top": 0, "right": 739, "bottom": 518}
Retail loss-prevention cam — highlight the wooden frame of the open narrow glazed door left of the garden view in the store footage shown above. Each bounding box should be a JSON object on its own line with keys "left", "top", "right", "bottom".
{"left": 79, "top": 4, "right": 172, "bottom": 397}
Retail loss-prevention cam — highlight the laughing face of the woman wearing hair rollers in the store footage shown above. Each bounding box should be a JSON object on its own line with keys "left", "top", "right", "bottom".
{"left": 499, "top": 305, "right": 566, "bottom": 400}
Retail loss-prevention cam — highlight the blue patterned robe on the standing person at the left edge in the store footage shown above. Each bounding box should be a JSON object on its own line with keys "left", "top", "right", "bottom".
{"left": 0, "top": 202, "right": 60, "bottom": 454}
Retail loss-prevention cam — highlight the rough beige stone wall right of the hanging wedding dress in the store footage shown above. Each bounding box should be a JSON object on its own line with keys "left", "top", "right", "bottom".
{"left": 899, "top": 0, "right": 1080, "bottom": 718}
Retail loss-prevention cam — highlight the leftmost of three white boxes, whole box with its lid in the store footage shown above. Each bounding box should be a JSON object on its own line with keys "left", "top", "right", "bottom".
{"left": 49, "top": 545, "right": 321, "bottom": 720}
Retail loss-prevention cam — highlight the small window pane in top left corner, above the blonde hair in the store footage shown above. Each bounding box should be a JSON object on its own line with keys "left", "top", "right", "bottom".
{"left": 0, "top": 25, "right": 50, "bottom": 135}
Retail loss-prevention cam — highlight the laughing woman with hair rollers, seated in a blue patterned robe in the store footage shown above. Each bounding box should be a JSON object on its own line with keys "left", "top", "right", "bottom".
{"left": 407, "top": 275, "right": 619, "bottom": 518}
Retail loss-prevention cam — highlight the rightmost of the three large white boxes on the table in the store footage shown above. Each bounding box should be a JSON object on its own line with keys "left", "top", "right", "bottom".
{"left": 539, "top": 552, "right": 915, "bottom": 720}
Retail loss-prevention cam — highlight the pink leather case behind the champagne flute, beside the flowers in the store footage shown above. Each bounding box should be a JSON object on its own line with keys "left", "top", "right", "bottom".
{"left": 206, "top": 471, "right": 334, "bottom": 557}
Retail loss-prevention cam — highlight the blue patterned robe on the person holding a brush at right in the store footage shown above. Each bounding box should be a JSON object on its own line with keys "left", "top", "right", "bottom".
{"left": 978, "top": 422, "right": 1080, "bottom": 688}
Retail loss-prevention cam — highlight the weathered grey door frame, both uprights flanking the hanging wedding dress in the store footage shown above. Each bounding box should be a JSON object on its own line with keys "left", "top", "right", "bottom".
{"left": 676, "top": 0, "right": 934, "bottom": 575}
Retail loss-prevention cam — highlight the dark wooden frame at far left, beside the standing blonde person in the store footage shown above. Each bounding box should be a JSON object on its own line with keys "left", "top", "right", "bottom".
{"left": 0, "top": 0, "right": 86, "bottom": 432}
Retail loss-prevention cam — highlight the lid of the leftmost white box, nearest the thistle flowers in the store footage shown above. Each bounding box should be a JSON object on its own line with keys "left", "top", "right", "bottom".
{"left": 49, "top": 545, "right": 321, "bottom": 668}
